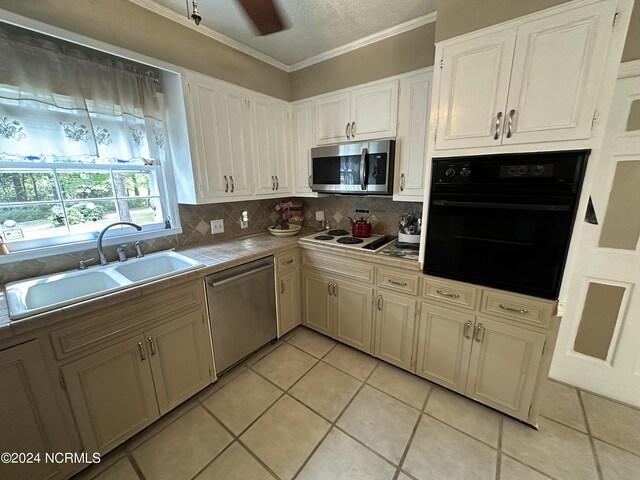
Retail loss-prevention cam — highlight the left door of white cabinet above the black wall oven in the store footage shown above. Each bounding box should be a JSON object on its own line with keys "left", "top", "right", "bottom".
{"left": 436, "top": 28, "right": 516, "bottom": 150}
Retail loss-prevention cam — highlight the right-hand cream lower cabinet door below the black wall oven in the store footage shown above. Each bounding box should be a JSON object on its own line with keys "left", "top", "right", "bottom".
{"left": 466, "top": 317, "right": 546, "bottom": 419}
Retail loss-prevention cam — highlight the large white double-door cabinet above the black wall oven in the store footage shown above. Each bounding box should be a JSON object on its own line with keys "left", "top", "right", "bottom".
{"left": 435, "top": 2, "right": 615, "bottom": 150}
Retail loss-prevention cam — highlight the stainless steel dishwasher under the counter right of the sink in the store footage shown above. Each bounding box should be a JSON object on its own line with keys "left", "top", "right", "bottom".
{"left": 205, "top": 256, "right": 277, "bottom": 374}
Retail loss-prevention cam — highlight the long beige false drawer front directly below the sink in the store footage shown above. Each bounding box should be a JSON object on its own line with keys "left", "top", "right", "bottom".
{"left": 50, "top": 280, "right": 204, "bottom": 359}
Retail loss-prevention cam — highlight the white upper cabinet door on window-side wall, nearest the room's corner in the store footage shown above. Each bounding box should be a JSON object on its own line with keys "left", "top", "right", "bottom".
{"left": 269, "top": 102, "right": 291, "bottom": 194}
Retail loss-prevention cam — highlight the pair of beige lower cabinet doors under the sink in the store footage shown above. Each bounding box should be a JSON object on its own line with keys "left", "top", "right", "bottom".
{"left": 61, "top": 311, "right": 212, "bottom": 453}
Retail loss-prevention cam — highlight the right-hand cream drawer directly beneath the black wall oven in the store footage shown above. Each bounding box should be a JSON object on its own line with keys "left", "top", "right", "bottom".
{"left": 480, "top": 290, "right": 555, "bottom": 328}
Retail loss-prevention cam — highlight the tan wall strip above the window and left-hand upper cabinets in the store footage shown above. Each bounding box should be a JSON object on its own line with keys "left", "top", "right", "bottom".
{"left": 0, "top": 0, "right": 289, "bottom": 100}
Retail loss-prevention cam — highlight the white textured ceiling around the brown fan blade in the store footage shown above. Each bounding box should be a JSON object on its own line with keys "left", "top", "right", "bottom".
{"left": 132, "top": 0, "right": 436, "bottom": 66}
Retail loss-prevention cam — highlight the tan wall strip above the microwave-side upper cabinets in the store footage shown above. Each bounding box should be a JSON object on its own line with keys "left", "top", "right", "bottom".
{"left": 290, "top": 22, "right": 436, "bottom": 101}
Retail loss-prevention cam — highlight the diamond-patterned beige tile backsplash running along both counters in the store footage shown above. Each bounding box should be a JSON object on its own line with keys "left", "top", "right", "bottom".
{"left": 0, "top": 196, "right": 422, "bottom": 285}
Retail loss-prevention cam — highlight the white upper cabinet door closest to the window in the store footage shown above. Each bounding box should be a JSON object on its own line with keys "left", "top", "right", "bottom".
{"left": 189, "top": 79, "right": 231, "bottom": 201}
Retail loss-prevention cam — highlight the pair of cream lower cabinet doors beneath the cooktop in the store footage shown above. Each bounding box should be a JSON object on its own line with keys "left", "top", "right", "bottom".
{"left": 302, "top": 270, "right": 373, "bottom": 353}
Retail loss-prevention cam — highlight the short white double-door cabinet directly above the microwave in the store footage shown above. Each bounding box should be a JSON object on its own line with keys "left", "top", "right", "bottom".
{"left": 315, "top": 80, "right": 398, "bottom": 145}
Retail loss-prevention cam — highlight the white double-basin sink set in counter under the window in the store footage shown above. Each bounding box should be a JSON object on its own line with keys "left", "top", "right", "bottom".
{"left": 5, "top": 251, "right": 203, "bottom": 320}
